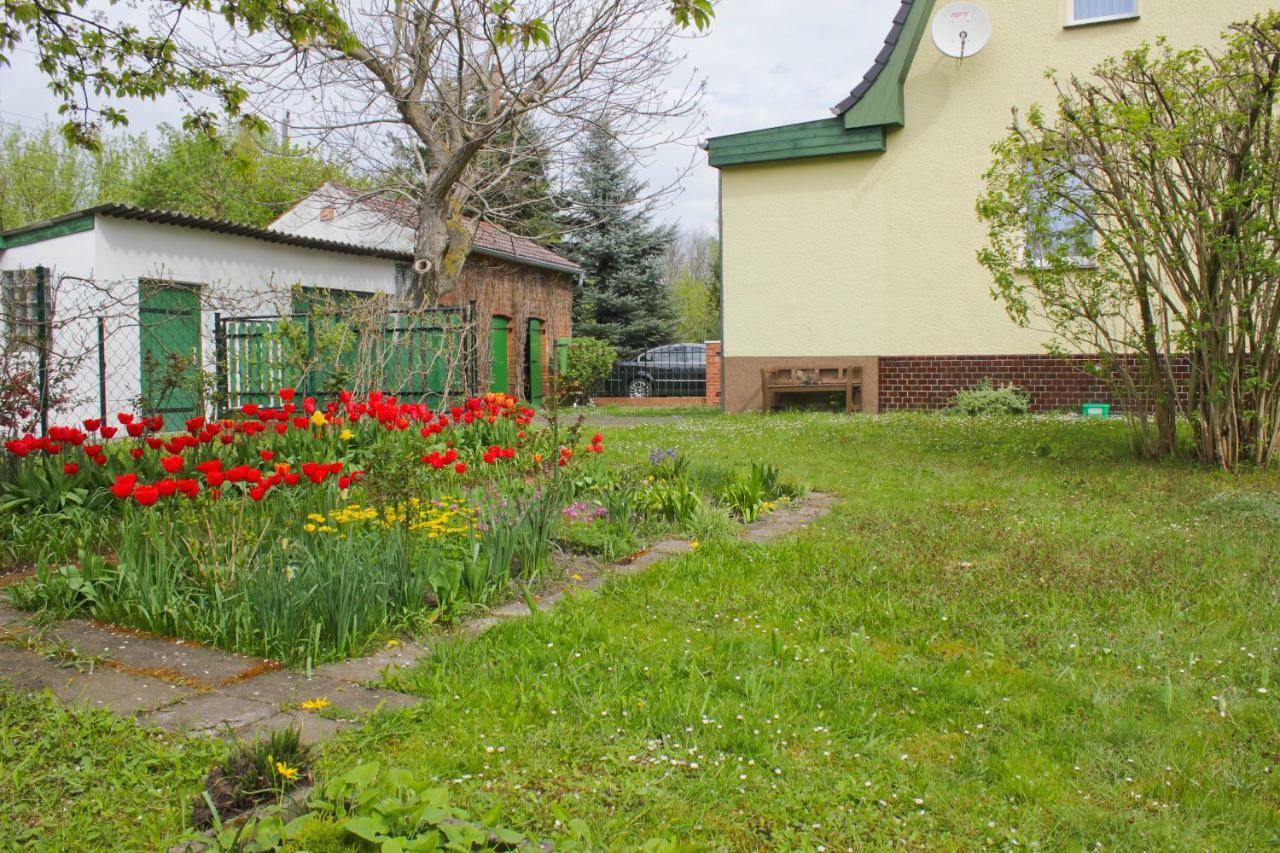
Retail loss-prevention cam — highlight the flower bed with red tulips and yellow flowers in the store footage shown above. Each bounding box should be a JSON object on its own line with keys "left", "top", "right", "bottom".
{"left": 0, "top": 388, "right": 787, "bottom": 665}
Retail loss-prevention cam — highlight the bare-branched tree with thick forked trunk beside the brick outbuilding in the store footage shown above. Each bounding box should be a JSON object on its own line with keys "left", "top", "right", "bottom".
{"left": 188, "top": 0, "right": 710, "bottom": 304}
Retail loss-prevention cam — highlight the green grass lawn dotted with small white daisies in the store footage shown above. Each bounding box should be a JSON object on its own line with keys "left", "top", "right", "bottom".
{"left": 0, "top": 415, "right": 1280, "bottom": 849}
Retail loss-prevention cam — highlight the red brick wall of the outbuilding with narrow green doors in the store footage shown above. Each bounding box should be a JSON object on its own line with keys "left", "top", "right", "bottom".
{"left": 440, "top": 255, "right": 573, "bottom": 397}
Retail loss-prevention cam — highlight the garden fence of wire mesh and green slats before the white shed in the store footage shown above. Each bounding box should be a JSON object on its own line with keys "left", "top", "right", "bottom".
{"left": 0, "top": 268, "right": 477, "bottom": 435}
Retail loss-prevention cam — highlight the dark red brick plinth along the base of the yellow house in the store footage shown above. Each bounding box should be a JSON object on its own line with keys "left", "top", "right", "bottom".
{"left": 879, "top": 355, "right": 1187, "bottom": 411}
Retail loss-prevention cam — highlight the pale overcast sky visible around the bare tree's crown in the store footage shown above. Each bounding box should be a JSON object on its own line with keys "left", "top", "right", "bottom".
{"left": 0, "top": 0, "right": 900, "bottom": 231}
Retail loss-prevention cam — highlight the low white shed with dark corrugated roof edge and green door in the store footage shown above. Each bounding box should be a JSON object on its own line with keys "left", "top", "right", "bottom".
{"left": 0, "top": 204, "right": 410, "bottom": 432}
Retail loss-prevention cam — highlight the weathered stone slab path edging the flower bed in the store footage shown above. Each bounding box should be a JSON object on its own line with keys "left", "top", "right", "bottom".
{"left": 0, "top": 493, "right": 835, "bottom": 743}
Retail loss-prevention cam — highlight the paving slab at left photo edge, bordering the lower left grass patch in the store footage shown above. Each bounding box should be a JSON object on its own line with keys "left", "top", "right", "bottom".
{"left": 0, "top": 646, "right": 195, "bottom": 715}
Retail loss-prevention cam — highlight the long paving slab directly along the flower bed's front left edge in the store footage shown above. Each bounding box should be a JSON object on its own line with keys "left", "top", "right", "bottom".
{"left": 50, "top": 620, "right": 262, "bottom": 688}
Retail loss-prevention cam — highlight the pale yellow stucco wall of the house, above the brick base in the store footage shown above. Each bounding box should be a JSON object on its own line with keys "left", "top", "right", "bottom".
{"left": 721, "top": 0, "right": 1280, "bottom": 356}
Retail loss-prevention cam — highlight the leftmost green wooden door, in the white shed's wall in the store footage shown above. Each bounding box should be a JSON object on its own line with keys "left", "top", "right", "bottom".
{"left": 138, "top": 282, "right": 201, "bottom": 430}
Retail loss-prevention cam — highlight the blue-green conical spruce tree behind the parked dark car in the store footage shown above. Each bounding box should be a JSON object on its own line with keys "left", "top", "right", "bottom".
{"left": 559, "top": 128, "right": 675, "bottom": 352}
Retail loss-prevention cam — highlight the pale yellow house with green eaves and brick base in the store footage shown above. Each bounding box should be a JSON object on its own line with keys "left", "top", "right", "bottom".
{"left": 708, "top": 0, "right": 1280, "bottom": 411}
